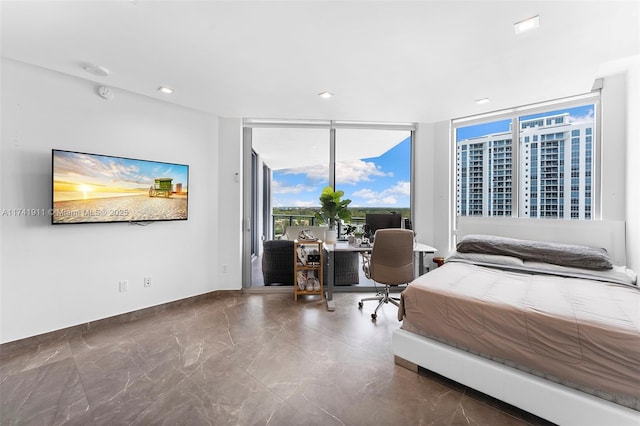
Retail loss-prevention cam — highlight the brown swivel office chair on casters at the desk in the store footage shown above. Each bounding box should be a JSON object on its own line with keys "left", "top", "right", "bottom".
{"left": 358, "top": 228, "right": 414, "bottom": 320}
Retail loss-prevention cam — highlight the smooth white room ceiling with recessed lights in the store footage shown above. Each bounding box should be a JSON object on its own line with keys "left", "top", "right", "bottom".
{"left": 0, "top": 0, "right": 640, "bottom": 122}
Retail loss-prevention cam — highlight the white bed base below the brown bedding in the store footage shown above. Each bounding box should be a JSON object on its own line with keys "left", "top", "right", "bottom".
{"left": 392, "top": 329, "right": 640, "bottom": 426}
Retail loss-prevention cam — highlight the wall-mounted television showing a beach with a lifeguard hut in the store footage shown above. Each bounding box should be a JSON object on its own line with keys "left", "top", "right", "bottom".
{"left": 51, "top": 149, "right": 189, "bottom": 225}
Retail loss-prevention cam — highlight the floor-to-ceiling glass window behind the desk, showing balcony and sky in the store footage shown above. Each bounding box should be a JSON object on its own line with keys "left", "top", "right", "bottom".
{"left": 245, "top": 120, "right": 414, "bottom": 286}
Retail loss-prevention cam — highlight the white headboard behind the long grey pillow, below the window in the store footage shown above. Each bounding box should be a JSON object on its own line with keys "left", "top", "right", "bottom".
{"left": 457, "top": 216, "right": 627, "bottom": 265}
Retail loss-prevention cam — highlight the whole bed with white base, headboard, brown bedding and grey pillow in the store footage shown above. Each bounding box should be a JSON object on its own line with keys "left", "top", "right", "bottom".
{"left": 393, "top": 219, "right": 640, "bottom": 425}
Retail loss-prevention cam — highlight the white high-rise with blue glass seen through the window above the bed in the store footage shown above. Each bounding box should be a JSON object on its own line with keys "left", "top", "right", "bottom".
{"left": 456, "top": 113, "right": 593, "bottom": 219}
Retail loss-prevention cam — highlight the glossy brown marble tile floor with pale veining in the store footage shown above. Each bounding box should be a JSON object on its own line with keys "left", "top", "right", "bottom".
{"left": 0, "top": 293, "right": 547, "bottom": 426}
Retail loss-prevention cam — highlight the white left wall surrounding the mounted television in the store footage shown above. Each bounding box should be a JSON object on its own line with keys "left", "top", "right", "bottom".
{"left": 0, "top": 60, "right": 225, "bottom": 343}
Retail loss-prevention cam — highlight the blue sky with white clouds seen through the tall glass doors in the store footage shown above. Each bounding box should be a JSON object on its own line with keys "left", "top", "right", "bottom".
{"left": 272, "top": 137, "right": 411, "bottom": 208}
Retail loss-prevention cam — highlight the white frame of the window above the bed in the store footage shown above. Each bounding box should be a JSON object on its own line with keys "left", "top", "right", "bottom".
{"left": 450, "top": 89, "right": 602, "bottom": 228}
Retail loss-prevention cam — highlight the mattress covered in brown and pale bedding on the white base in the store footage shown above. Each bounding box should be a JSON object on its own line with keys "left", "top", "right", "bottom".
{"left": 398, "top": 261, "right": 640, "bottom": 410}
